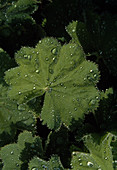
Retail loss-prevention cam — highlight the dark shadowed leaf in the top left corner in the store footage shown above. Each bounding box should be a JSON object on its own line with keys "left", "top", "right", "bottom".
{"left": 0, "top": 0, "right": 38, "bottom": 24}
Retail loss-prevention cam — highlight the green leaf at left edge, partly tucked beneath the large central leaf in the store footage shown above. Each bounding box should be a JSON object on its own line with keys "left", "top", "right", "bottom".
{"left": 0, "top": 85, "right": 35, "bottom": 145}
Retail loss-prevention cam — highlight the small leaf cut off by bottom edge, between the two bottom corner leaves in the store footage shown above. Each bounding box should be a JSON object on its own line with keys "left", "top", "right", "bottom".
{"left": 29, "top": 155, "right": 64, "bottom": 170}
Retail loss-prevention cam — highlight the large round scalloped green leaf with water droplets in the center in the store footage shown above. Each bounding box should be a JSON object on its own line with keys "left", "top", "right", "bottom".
{"left": 5, "top": 38, "right": 100, "bottom": 129}
